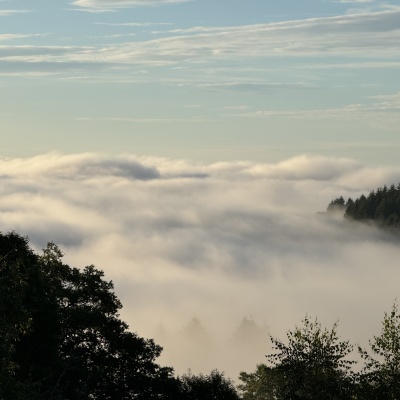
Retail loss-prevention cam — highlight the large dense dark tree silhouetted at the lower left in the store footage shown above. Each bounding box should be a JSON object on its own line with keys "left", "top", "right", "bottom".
{"left": 0, "top": 233, "right": 179, "bottom": 400}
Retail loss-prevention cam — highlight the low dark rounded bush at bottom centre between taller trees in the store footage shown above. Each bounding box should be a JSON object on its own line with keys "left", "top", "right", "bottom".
{"left": 177, "top": 371, "right": 239, "bottom": 400}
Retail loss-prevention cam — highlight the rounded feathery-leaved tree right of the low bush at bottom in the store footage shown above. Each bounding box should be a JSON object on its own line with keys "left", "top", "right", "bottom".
{"left": 241, "top": 316, "right": 354, "bottom": 400}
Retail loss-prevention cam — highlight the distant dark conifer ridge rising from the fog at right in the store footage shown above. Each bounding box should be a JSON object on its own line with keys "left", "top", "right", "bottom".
{"left": 327, "top": 184, "right": 400, "bottom": 228}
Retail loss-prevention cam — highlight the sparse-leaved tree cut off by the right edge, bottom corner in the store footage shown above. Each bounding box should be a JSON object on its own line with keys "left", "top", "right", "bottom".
{"left": 359, "top": 302, "right": 400, "bottom": 400}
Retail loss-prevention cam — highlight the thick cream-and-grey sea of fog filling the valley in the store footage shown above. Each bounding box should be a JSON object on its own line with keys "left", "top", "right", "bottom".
{"left": 0, "top": 153, "right": 400, "bottom": 378}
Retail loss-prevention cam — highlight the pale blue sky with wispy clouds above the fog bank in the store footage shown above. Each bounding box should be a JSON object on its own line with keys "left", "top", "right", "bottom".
{"left": 0, "top": 0, "right": 400, "bottom": 164}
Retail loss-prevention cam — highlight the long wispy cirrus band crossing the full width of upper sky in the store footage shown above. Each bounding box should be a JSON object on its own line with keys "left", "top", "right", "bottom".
{"left": 0, "top": 9, "right": 400, "bottom": 76}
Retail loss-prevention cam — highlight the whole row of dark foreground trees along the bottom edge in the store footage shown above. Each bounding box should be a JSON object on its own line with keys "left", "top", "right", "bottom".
{"left": 0, "top": 230, "right": 400, "bottom": 400}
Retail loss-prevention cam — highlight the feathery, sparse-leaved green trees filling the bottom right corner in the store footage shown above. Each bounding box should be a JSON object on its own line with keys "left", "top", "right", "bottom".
{"left": 239, "top": 303, "right": 400, "bottom": 400}
